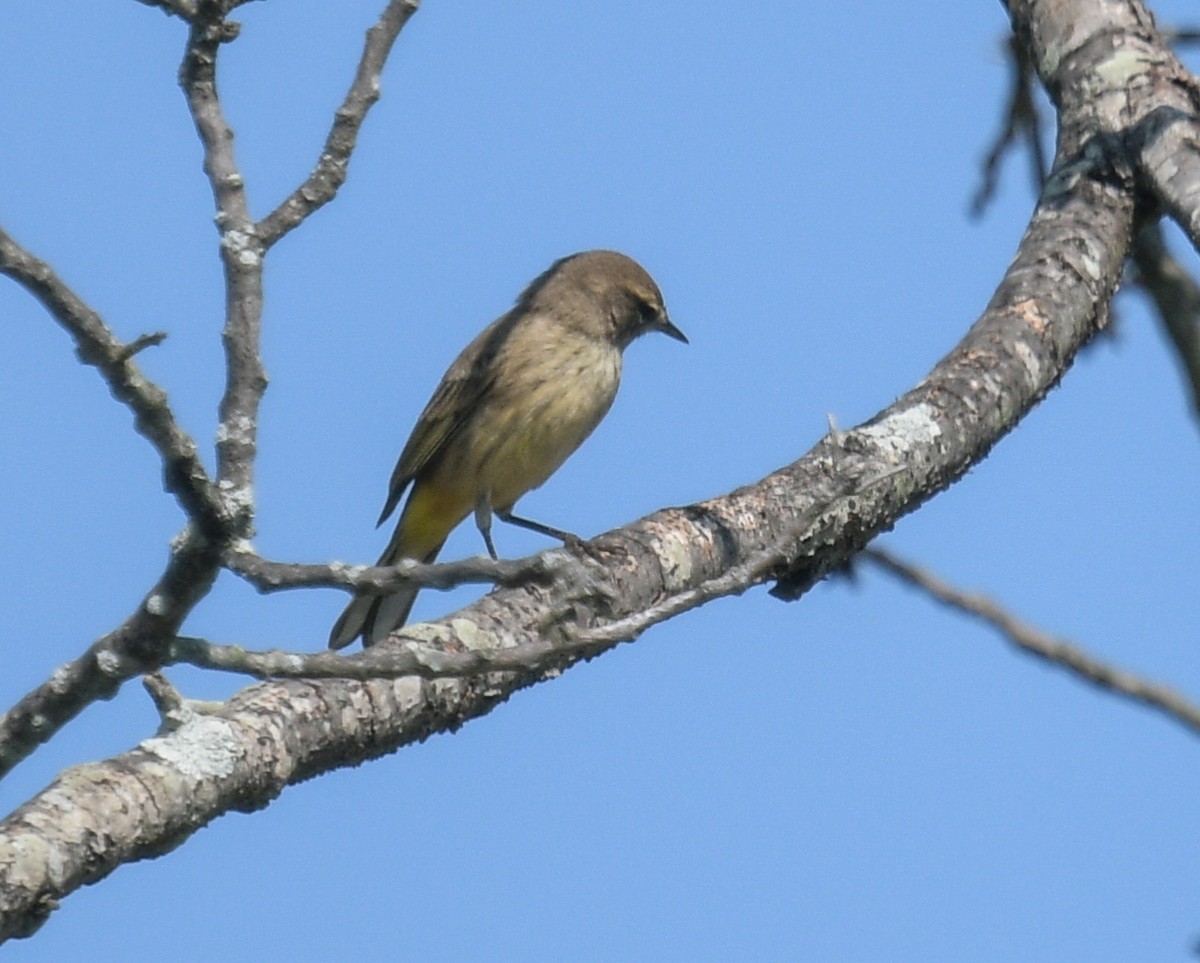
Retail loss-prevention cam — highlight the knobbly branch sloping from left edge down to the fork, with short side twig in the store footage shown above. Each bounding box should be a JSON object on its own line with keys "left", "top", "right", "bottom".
{"left": 0, "top": 229, "right": 226, "bottom": 528}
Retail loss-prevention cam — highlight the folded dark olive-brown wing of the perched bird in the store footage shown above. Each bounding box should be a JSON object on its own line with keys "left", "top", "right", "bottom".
{"left": 378, "top": 310, "right": 523, "bottom": 525}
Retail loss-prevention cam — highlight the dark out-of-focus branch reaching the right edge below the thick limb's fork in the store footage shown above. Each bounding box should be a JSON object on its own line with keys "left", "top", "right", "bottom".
{"left": 1133, "top": 222, "right": 1200, "bottom": 418}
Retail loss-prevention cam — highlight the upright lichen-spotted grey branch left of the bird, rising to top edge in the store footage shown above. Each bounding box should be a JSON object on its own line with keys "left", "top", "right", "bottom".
{"left": 179, "top": 0, "right": 266, "bottom": 518}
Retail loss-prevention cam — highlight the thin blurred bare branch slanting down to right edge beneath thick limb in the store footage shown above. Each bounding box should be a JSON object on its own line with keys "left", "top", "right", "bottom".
{"left": 863, "top": 549, "right": 1200, "bottom": 735}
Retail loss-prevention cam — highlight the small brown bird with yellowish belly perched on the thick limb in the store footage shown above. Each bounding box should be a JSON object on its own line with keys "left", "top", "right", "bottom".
{"left": 329, "top": 251, "right": 688, "bottom": 648}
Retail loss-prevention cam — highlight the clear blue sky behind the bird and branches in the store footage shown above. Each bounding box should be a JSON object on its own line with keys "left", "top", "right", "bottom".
{"left": 0, "top": 0, "right": 1200, "bottom": 963}
